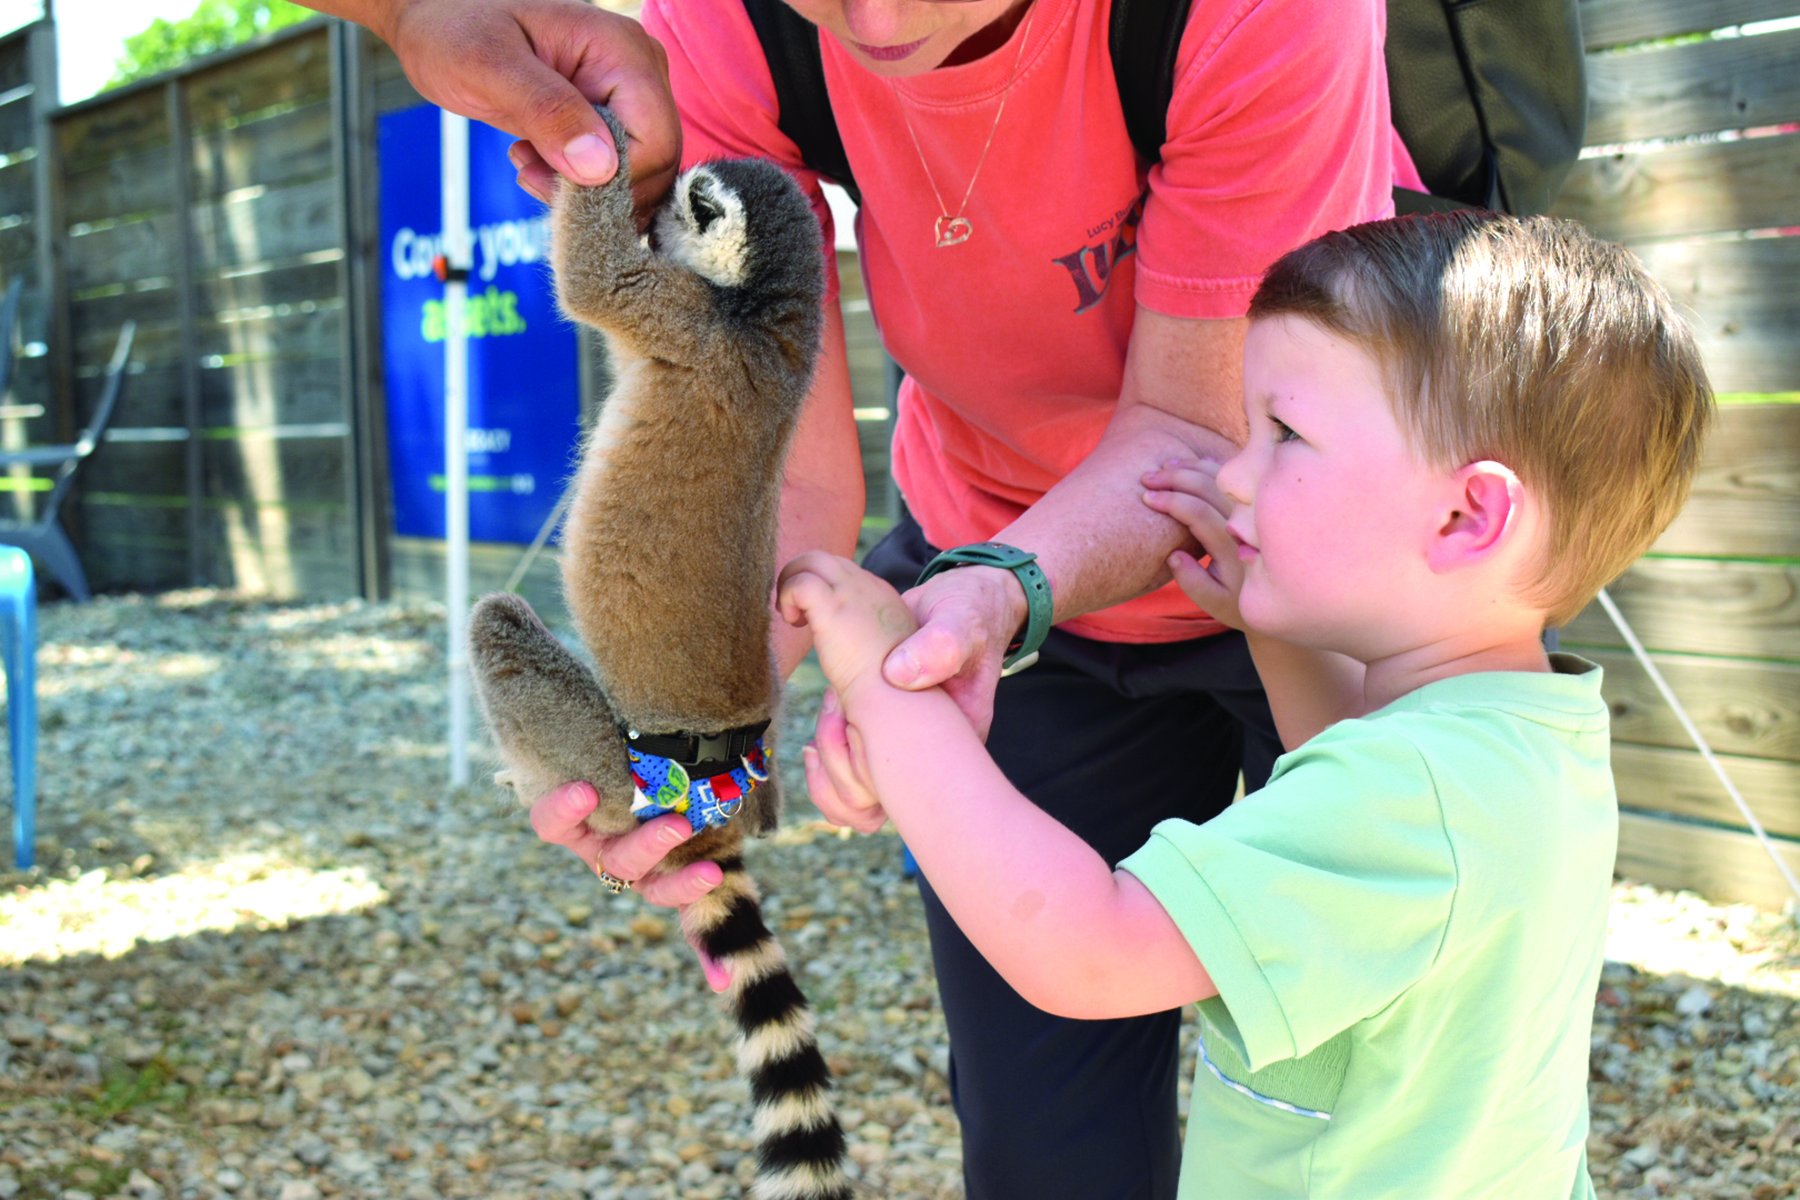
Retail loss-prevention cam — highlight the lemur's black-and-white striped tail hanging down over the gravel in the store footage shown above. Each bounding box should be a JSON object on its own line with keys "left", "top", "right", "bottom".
{"left": 686, "top": 856, "right": 851, "bottom": 1200}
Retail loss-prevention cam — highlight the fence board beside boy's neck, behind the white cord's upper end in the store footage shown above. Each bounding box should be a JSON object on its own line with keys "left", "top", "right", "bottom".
{"left": 1562, "top": 558, "right": 1800, "bottom": 662}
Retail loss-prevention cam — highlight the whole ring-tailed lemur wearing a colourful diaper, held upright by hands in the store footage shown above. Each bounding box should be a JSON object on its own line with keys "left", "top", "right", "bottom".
{"left": 470, "top": 110, "right": 851, "bottom": 1200}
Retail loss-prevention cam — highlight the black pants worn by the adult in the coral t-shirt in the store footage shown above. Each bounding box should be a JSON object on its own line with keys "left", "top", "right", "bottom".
{"left": 864, "top": 520, "right": 1280, "bottom": 1200}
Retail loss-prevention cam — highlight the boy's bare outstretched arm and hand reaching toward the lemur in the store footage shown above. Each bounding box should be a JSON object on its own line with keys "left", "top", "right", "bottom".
{"left": 781, "top": 554, "right": 1217, "bottom": 1020}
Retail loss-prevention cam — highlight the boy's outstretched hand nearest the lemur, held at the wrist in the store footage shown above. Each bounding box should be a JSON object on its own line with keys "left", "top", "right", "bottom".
{"left": 776, "top": 551, "right": 918, "bottom": 705}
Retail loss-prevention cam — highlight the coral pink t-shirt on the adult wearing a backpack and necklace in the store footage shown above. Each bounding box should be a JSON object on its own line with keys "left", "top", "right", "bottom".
{"left": 643, "top": 0, "right": 1415, "bottom": 642}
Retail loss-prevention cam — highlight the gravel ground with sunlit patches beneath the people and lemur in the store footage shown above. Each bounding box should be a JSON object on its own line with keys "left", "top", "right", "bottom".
{"left": 0, "top": 592, "right": 1800, "bottom": 1200}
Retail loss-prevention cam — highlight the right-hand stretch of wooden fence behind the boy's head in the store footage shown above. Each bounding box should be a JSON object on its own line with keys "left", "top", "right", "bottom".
{"left": 1557, "top": 0, "right": 1800, "bottom": 907}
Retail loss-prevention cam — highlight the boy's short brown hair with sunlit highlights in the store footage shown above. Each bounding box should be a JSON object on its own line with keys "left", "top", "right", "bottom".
{"left": 1249, "top": 212, "right": 1712, "bottom": 626}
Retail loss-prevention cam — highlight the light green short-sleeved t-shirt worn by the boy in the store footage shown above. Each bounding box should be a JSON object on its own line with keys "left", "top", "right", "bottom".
{"left": 1120, "top": 655, "right": 1618, "bottom": 1200}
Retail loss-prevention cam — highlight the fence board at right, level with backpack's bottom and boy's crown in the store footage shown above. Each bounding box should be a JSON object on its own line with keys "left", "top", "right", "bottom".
{"left": 1552, "top": 133, "right": 1800, "bottom": 241}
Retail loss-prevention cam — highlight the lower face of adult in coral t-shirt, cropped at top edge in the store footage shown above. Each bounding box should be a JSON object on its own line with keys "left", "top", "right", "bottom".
{"left": 787, "top": 0, "right": 1033, "bottom": 79}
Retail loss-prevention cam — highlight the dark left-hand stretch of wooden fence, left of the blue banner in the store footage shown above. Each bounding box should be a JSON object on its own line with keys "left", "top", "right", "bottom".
{"left": 7, "top": 18, "right": 430, "bottom": 596}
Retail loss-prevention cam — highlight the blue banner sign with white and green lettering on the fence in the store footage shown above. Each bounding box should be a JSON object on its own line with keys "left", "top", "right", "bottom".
{"left": 378, "top": 104, "right": 581, "bottom": 543}
